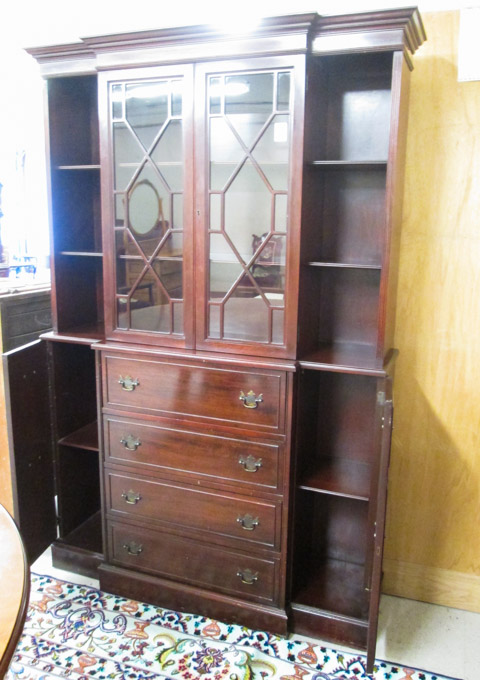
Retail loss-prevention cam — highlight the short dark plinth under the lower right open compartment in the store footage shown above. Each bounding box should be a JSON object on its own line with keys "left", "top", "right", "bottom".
{"left": 290, "top": 603, "right": 368, "bottom": 649}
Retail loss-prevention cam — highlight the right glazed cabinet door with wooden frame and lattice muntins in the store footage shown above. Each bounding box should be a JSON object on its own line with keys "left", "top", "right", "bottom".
{"left": 195, "top": 57, "right": 305, "bottom": 357}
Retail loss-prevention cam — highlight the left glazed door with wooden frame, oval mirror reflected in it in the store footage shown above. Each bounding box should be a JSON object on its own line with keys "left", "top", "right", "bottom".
{"left": 99, "top": 65, "right": 193, "bottom": 347}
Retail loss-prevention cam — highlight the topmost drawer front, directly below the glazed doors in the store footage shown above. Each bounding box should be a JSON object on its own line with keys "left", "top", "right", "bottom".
{"left": 104, "top": 356, "right": 286, "bottom": 431}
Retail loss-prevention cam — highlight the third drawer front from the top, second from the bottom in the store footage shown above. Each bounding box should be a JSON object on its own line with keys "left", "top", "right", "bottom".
{"left": 106, "top": 471, "right": 281, "bottom": 549}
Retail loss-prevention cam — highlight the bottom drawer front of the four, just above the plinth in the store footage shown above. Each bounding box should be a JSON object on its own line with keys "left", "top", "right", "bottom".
{"left": 108, "top": 522, "right": 279, "bottom": 604}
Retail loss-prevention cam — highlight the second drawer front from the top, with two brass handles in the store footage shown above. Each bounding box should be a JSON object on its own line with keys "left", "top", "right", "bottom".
{"left": 104, "top": 416, "right": 283, "bottom": 493}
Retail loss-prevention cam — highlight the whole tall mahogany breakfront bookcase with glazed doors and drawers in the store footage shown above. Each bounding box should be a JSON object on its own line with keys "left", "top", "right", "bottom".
{"left": 16, "top": 8, "right": 425, "bottom": 668}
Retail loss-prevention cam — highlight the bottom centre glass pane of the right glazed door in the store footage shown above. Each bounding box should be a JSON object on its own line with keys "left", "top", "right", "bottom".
{"left": 224, "top": 297, "right": 269, "bottom": 342}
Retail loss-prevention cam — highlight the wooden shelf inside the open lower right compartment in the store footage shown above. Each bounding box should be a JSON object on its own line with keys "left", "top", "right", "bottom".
{"left": 298, "top": 458, "right": 371, "bottom": 501}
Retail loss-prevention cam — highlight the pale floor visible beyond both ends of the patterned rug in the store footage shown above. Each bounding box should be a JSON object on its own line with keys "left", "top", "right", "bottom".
{"left": 32, "top": 550, "right": 474, "bottom": 680}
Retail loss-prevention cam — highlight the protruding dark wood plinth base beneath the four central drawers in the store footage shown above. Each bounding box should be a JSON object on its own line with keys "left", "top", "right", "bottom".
{"left": 98, "top": 564, "right": 287, "bottom": 635}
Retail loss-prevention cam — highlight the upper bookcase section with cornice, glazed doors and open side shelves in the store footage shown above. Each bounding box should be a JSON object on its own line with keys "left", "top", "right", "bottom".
{"left": 30, "top": 8, "right": 425, "bottom": 362}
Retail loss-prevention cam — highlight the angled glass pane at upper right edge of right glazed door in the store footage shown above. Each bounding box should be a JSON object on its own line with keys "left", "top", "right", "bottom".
{"left": 253, "top": 115, "right": 290, "bottom": 191}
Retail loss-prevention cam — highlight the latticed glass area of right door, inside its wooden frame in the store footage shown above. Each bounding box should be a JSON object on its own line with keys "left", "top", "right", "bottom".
{"left": 208, "top": 72, "right": 291, "bottom": 344}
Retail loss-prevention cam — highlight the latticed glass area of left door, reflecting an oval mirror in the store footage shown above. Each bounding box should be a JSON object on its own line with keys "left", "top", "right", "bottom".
{"left": 111, "top": 79, "right": 184, "bottom": 336}
